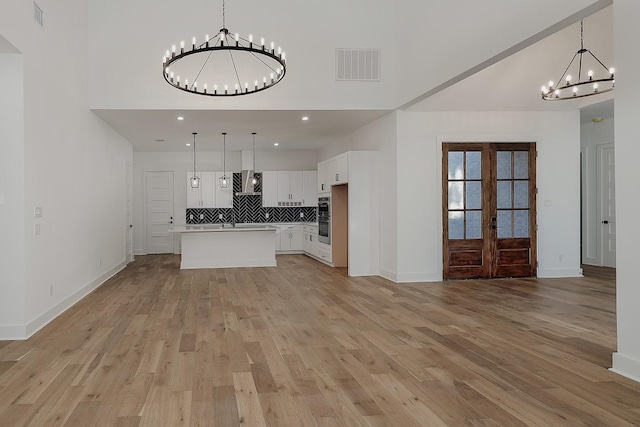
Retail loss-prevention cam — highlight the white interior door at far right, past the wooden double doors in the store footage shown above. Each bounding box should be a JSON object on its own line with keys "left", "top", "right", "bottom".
{"left": 598, "top": 144, "right": 616, "bottom": 267}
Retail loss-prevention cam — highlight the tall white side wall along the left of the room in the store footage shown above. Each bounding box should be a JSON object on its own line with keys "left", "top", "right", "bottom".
{"left": 0, "top": 0, "right": 132, "bottom": 339}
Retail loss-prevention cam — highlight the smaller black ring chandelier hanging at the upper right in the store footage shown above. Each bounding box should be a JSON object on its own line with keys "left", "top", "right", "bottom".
{"left": 541, "top": 20, "right": 615, "bottom": 101}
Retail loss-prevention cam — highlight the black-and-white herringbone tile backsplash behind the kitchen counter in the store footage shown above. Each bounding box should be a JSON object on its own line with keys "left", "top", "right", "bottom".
{"left": 186, "top": 173, "right": 317, "bottom": 224}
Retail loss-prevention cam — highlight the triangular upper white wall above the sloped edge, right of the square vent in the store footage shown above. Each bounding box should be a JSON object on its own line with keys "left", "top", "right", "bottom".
{"left": 395, "top": 0, "right": 610, "bottom": 109}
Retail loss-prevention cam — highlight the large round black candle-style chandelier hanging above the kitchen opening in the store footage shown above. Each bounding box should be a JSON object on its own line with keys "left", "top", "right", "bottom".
{"left": 162, "top": 0, "right": 286, "bottom": 96}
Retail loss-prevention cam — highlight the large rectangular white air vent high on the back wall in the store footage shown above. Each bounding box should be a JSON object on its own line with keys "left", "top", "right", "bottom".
{"left": 336, "top": 48, "right": 380, "bottom": 82}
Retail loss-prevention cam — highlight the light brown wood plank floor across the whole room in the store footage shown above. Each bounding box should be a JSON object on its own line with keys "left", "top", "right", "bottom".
{"left": 0, "top": 255, "right": 640, "bottom": 427}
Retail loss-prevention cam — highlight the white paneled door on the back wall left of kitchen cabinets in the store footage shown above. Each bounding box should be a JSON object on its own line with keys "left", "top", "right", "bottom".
{"left": 145, "top": 171, "right": 173, "bottom": 254}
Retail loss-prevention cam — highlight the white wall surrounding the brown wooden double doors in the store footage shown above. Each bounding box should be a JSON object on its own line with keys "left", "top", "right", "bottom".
{"left": 392, "top": 111, "right": 581, "bottom": 281}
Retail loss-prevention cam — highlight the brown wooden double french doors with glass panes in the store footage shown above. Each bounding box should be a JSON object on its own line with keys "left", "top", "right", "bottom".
{"left": 442, "top": 143, "right": 537, "bottom": 279}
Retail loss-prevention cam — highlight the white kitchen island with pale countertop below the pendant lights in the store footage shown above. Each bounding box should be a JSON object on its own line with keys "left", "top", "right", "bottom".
{"left": 170, "top": 224, "right": 276, "bottom": 269}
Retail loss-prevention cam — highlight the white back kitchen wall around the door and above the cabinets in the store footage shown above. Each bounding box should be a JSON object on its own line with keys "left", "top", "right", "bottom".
{"left": 133, "top": 151, "right": 318, "bottom": 254}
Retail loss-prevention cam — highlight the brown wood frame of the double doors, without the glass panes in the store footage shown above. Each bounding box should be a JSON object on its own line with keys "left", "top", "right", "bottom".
{"left": 440, "top": 142, "right": 538, "bottom": 279}
